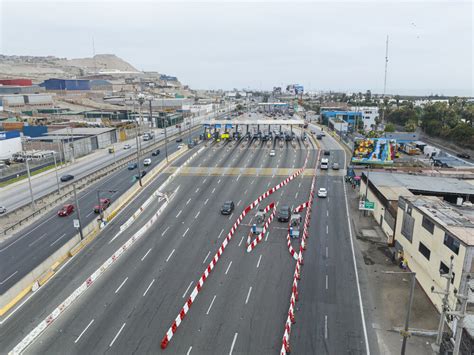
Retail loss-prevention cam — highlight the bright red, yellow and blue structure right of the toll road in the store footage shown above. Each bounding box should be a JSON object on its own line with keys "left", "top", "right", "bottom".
{"left": 351, "top": 138, "right": 397, "bottom": 165}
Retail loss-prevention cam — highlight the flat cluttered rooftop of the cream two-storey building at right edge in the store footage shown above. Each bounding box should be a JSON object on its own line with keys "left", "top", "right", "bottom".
{"left": 403, "top": 196, "right": 474, "bottom": 246}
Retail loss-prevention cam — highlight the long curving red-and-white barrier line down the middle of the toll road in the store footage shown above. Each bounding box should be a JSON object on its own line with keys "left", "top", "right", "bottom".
{"left": 161, "top": 151, "right": 309, "bottom": 349}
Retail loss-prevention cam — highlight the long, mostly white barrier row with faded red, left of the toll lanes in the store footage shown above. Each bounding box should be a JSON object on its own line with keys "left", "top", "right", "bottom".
{"left": 8, "top": 189, "right": 178, "bottom": 355}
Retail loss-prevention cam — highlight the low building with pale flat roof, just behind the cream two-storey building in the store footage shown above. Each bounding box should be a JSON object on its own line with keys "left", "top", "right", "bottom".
{"left": 360, "top": 171, "right": 474, "bottom": 245}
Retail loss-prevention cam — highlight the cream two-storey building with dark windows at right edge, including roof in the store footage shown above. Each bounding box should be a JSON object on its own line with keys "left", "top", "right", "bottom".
{"left": 395, "top": 196, "right": 474, "bottom": 320}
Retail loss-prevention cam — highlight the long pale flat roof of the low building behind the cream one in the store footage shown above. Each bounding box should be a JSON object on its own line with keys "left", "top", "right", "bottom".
{"left": 362, "top": 171, "right": 474, "bottom": 195}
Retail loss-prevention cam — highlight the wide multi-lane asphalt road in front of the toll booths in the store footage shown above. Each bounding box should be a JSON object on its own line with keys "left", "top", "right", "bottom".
{"left": 0, "top": 123, "right": 376, "bottom": 354}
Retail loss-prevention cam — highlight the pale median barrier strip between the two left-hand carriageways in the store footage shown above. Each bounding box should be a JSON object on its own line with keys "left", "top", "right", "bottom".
{"left": 1, "top": 127, "right": 199, "bottom": 235}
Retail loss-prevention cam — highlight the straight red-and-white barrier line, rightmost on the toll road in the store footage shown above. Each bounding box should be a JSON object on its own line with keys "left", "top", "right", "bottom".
{"left": 280, "top": 151, "right": 321, "bottom": 355}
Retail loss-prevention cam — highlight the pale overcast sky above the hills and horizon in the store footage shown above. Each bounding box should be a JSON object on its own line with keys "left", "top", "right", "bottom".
{"left": 0, "top": 0, "right": 474, "bottom": 95}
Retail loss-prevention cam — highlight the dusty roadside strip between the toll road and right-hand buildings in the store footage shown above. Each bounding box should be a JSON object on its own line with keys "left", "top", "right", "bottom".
{"left": 347, "top": 185, "right": 439, "bottom": 355}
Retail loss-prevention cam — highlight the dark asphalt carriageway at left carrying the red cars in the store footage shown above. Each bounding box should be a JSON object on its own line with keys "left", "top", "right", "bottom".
{"left": 0, "top": 132, "right": 198, "bottom": 294}
